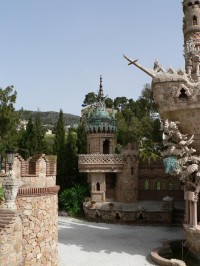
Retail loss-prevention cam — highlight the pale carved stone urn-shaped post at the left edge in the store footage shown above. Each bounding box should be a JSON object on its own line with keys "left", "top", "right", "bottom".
{"left": 1, "top": 171, "right": 22, "bottom": 211}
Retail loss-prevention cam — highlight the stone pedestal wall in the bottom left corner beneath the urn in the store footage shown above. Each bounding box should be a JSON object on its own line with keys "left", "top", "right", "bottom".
{"left": 0, "top": 214, "right": 24, "bottom": 266}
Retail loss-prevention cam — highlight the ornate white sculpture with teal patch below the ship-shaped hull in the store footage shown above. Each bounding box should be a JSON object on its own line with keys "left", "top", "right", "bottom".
{"left": 161, "top": 120, "right": 200, "bottom": 195}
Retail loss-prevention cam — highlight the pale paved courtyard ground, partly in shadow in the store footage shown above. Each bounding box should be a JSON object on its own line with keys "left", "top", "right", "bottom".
{"left": 58, "top": 217, "right": 184, "bottom": 266}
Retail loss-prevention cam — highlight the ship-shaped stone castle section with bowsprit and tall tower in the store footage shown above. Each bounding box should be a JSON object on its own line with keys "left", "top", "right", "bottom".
{"left": 124, "top": 0, "right": 200, "bottom": 154}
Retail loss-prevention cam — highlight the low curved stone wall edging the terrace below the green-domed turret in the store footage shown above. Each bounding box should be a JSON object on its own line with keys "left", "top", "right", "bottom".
{"left": 83, "top": 204, "right": 173, "bottom": 224}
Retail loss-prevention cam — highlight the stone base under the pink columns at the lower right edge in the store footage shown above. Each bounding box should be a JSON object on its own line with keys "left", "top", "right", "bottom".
{"left": 183, "top": 224, "right": 200, "bottom": 260}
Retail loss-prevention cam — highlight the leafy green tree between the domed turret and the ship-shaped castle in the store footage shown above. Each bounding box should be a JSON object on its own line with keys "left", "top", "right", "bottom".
{"left": 114, "top": 84, "right": 162, "bottom": 158}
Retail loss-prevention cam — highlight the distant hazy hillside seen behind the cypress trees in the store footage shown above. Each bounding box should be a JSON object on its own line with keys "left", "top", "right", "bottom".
{"left": 21, "top": 110, "right": 80, "bottom": 126}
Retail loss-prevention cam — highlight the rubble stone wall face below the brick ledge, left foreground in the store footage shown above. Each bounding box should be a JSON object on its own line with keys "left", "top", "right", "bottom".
{"left": 16, "top": 192, "right": 58, "bottom": 266}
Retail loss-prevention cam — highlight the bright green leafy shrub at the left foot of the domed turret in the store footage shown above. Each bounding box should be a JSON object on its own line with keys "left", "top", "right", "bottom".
{"left": 59, "top": 185, "right": 89, "bottom": 216}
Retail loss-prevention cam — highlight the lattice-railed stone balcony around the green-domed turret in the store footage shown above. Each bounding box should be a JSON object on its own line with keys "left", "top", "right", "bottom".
{"left": 78, "top": 154, "right": 124, "bottom": 173}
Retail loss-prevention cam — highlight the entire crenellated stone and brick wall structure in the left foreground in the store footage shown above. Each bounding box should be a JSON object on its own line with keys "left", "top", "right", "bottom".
{"left": 0, "top": 155, "right": 59, "bottom": 266}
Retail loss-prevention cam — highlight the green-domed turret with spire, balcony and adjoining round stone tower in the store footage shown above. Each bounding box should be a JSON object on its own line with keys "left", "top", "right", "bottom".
{"left": 79, "top": 77, "right": 138, "bottom": 202}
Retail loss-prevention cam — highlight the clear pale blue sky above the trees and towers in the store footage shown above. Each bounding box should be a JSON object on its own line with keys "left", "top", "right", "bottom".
{"left": 0, "top": 0, "right": 184, "bottom": 115}
